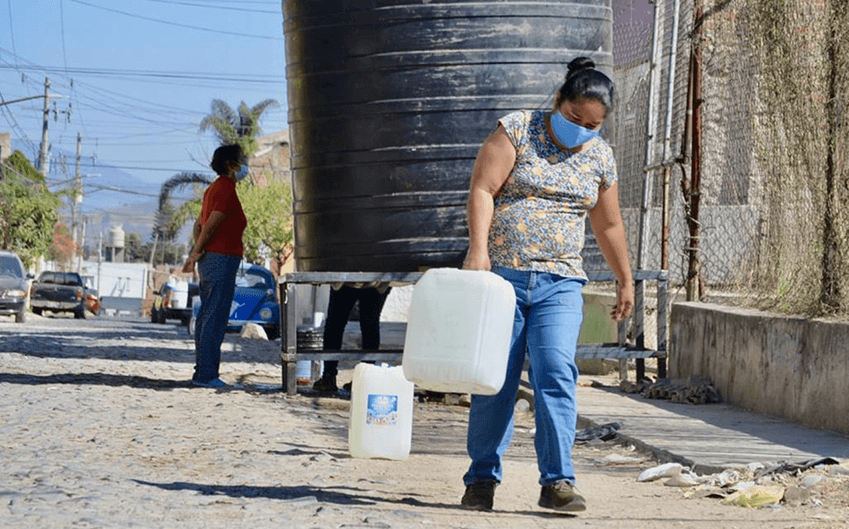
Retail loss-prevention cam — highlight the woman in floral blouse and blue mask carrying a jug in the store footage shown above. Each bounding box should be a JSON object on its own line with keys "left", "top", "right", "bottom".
{"left": 461, "top": 57, "right": 634, "bottom": 512}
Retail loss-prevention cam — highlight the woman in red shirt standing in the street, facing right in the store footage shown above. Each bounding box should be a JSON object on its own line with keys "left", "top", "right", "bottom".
{"left": 183, "top": 145, "right": 248, "bottom": 388}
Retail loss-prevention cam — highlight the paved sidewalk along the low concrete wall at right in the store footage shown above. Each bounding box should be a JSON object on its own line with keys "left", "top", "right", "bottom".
{"left": 578, "top": 377, "right": 849, "bottom": 474}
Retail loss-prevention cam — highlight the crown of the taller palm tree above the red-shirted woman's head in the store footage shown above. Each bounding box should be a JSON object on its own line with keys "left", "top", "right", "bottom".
{"left": 200, "top": 99, "right": 278, "bottom": 157}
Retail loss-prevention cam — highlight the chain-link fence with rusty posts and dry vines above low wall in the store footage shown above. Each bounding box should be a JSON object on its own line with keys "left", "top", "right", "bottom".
{"left": 613, "top": 0, "right": 849, "bottom": 316}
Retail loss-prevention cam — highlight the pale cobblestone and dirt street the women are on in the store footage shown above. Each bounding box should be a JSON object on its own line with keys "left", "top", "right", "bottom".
{"left": 0, "top": 315, "right": 849, "bottom": 529}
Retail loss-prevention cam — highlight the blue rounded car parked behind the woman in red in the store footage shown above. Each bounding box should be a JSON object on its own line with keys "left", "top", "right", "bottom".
{"left": 188, "top": 261, "right": 280, "bottom": 340}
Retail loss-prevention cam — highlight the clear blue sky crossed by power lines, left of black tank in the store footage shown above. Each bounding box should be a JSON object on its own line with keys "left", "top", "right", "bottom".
{"left": 0, "top": 0, "right": 287, "bottom": 235}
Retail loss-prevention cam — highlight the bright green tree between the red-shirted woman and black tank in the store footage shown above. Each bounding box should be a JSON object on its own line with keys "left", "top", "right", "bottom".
{"left": 236, "top": 174, "right": 295, "bottom": 270}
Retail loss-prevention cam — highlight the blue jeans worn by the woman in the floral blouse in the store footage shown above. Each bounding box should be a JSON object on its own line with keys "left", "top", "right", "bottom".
{"left": 463, "top": 266, "right": 584, "bottom": 485}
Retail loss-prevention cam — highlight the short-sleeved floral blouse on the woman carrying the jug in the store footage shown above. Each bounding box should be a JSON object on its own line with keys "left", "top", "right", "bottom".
{"left": 489, "top": 110, "right": 617, "bottom": 281}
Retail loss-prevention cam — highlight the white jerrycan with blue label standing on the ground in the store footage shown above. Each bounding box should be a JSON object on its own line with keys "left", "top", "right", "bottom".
{"left": 348, "top": 363, "right": 414, "bottom": 459}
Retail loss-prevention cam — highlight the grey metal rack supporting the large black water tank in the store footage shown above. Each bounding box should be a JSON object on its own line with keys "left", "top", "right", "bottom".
{"left": 278, "top": 270, "right": 668, "bottom": 395}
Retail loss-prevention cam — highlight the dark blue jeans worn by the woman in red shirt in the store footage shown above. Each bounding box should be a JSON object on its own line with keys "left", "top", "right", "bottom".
{"left": 192, "top": 252, "right": 242, "bottom": 382}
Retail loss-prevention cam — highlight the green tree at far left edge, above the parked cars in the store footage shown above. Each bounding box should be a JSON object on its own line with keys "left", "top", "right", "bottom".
{"left": 0, "top": 150, "right": 62, "bottom": 267}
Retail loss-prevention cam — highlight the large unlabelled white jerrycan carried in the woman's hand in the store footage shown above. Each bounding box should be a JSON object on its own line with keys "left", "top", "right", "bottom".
{"left": 401, "top": 268, "right": 516, "bottom": 395}
